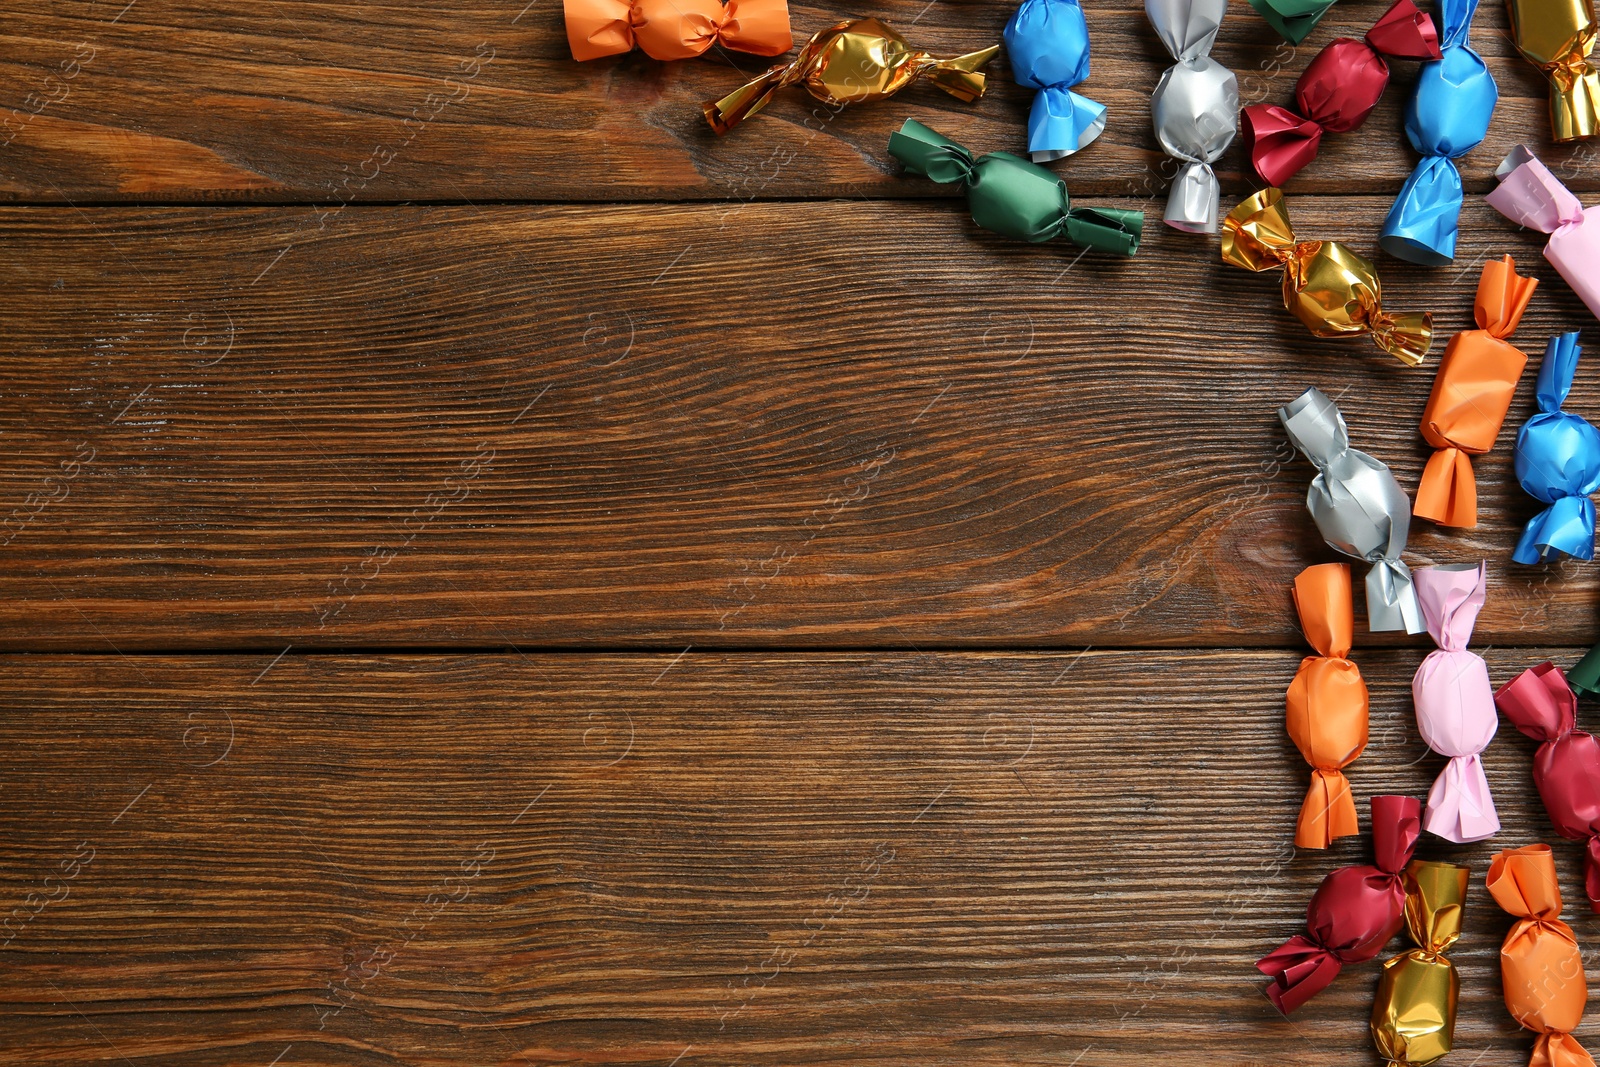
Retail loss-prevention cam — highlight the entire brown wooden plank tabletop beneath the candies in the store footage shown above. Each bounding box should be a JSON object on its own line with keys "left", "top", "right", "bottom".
{"left": 0, "top": 0, "right": 1600, "bottom": 1067}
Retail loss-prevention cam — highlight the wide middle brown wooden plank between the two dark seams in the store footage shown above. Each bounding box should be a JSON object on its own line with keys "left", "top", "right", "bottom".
{"left": 0, "top": 197, "right": 1600, "bottom": 651}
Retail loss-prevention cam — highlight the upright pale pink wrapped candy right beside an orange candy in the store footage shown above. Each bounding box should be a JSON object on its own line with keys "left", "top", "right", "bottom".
{"left": 1411, "top": 563, "right": 1499, "bottom": 845}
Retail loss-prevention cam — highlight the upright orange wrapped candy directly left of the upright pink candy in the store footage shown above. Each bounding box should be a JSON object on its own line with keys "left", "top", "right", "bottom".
{"left": 1283, "top": 563, "right": 1366, "bottom": 848}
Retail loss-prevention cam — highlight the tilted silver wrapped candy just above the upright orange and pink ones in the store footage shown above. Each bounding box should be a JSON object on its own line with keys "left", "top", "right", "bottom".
{"left": 1278, "top": 389, "right": 1424, "bottom": 633}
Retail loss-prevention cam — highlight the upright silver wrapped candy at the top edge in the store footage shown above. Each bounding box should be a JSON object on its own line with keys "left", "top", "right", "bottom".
{"left": 1144, "top": 0, "right": 1238, "bottom": 234}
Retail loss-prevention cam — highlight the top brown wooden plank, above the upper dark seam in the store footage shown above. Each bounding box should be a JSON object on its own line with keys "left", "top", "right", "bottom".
{"left": 0, "top": 0, "right": 1600, "bottom": 203}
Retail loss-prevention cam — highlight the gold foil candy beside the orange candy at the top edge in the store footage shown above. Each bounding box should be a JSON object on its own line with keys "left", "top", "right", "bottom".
{"left": 702, "top": 19, "right": 1000, "bottom": 134}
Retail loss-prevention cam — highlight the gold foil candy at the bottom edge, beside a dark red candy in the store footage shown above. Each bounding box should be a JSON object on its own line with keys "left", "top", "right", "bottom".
{"left": 1371, "top": 859, "right": 1470, "bottom": 1067}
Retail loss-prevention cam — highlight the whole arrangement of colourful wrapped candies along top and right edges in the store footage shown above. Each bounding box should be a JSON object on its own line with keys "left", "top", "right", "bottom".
{"left": 565, "top": 0, "right": 1600, "bottom": 1067}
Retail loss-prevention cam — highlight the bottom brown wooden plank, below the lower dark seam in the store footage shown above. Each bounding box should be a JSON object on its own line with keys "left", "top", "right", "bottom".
{"left": 0, "top": 649, "right": 1600, "bottom": 1067}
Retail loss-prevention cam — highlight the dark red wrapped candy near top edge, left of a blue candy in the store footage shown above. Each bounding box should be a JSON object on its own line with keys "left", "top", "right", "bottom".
{"left": 1240, "top": 0, "right": 1440, "bottom": 186}
